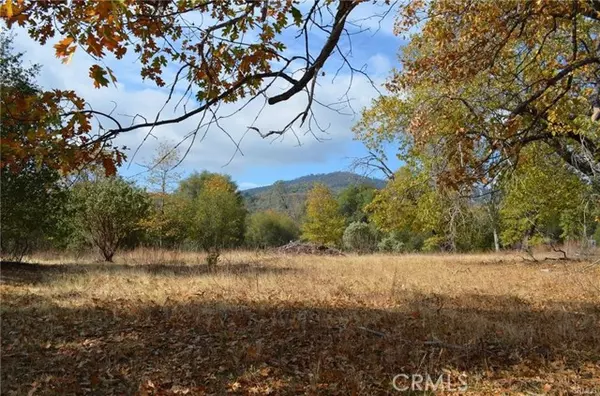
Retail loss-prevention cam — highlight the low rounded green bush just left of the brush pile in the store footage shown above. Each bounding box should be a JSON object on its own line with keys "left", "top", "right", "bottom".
{"left": 246, "top": 210, "right": 300, "bottom": 248}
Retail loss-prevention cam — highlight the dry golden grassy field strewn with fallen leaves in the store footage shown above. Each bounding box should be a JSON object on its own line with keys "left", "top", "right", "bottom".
{"left": 0, "top": 250, "right": 600, "bottom": 395}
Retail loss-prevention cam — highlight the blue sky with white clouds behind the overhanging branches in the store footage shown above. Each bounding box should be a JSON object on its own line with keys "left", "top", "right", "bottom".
{"left": 14, "top": 1, "right": 403, "bottom": 189}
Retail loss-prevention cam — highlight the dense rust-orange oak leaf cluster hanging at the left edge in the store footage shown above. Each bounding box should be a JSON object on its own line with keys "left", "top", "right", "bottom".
{"left": 0, "top": 31, "right": 124, "bottom": 174}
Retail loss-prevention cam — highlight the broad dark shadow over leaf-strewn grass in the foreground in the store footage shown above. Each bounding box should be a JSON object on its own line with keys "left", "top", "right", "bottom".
{"left": 1, "top": 295, "right": 600, "bottom": 395}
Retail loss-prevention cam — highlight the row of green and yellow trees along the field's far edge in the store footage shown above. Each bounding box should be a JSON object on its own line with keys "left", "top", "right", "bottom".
{"left": 0, "top": 142, "right": 600, "bottom": 264}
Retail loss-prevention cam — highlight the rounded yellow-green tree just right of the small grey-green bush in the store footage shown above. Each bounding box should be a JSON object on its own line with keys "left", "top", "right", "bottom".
{"left": 365, "top": 155, "right": 492, "bottom": 251}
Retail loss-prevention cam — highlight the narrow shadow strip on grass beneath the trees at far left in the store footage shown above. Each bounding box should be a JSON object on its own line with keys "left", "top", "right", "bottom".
{"left": 0, "top": 261, "right": 301, "bottom": 285}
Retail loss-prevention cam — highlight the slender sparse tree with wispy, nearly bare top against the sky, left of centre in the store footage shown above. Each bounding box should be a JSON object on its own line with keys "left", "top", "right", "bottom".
{"left": 144, "top": 142, "right": 181, "bottom": 247}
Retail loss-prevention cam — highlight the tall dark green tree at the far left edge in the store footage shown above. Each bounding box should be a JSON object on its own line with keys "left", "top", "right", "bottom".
{"left": 0, "top": 34, "right": 67, "bottom": 260}
